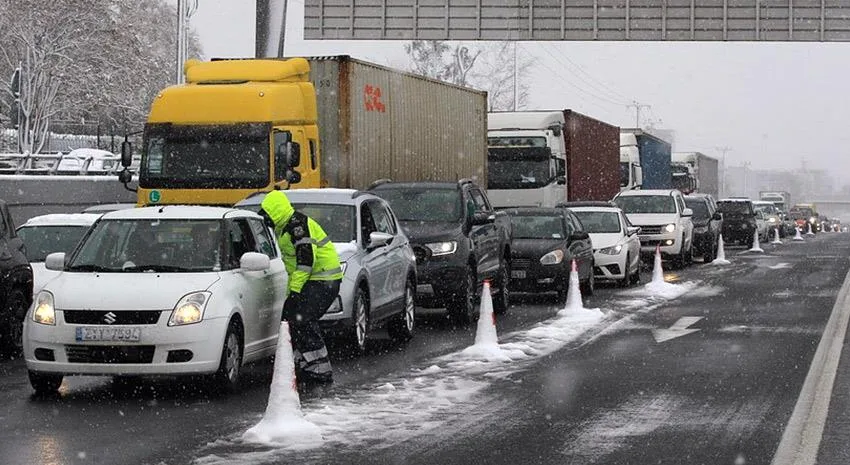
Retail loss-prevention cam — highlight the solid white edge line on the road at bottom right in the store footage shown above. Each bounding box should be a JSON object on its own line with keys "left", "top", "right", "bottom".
{"left": 771, "top": 264, "right": 850, "bottom": 465}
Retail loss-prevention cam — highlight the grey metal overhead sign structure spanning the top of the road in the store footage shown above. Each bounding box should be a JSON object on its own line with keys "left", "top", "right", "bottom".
{"left": 296, "top": 0, "right": 850, "bottom": 42}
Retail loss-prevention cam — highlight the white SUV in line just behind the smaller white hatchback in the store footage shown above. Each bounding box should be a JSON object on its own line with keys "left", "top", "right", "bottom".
{"left": 614, "top": 189, "right": 694, "bottom": 268}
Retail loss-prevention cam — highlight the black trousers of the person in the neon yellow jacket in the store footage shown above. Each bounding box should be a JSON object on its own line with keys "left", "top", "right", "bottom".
{"left": 282, "top": 280, "right": 341, "bottom": 379}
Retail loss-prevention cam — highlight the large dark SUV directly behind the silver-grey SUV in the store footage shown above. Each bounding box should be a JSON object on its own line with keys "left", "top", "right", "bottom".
{"left": 370, "top": 180, "right": 511, "bottom": 324}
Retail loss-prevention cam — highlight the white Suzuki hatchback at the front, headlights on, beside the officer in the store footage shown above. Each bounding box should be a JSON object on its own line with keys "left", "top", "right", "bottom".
{"left": 23, "top": 206, "right": 287, "bottom": 393}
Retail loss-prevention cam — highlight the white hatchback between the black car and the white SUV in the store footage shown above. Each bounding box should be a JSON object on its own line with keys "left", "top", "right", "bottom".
{"left": 563, "top": 202, "right": 640, "bottom": 287}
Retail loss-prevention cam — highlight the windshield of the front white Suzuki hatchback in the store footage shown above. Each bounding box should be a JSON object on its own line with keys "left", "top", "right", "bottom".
{"left": 67, "top": 219, "right": 223, "bottom": 273}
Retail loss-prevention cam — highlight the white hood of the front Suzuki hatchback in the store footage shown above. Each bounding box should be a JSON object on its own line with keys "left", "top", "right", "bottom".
{"left": 44, "top": 271, "right": 220, "bottom": 310}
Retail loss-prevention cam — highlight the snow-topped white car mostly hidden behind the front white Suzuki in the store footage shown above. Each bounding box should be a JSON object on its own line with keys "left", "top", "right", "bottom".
{"left": 15, "top": 213, "right": 100, "bottom": 295}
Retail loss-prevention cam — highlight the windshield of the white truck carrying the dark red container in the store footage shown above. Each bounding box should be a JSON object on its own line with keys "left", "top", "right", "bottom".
{"left": 487, "top": 147, "right": 552, "bottom": 189}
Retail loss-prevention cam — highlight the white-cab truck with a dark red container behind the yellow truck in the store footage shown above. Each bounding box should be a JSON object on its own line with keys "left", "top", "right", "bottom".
{"left": 487, "top": 110, "right": 620, "bottom": 208}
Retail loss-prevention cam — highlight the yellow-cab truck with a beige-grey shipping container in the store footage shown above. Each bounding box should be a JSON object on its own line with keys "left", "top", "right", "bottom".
{"left": 121, "top": 56, "right": 487, "bottom": 205}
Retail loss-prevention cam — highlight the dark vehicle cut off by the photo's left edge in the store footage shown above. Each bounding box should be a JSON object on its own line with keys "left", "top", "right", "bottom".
{"left": 0, "top": 200, "right": 32, "bottom": 356}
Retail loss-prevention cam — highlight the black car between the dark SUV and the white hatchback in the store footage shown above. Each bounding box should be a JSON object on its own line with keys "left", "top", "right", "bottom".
{"left": 506, "top": 208, "right": 594, "bottom": 301}
